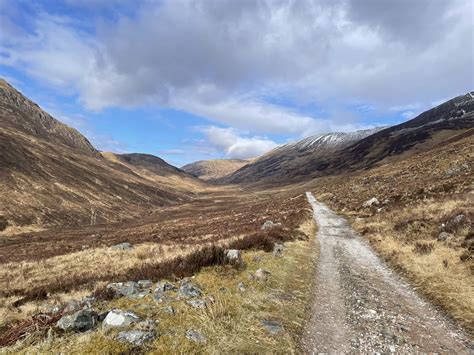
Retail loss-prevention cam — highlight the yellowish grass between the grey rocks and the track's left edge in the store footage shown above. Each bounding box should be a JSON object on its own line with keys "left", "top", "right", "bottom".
{"left": 1, "top": 220, "right": 317, "bottom": 354}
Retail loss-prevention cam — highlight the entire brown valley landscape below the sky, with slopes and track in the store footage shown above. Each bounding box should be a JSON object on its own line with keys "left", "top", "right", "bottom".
{"left": 0, "top": 81, "right": 474, "bottom": 353}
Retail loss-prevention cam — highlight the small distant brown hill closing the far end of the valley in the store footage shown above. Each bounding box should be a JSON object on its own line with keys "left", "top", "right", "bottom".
{"left": 181, "top": 159, "right": 252, "bottom": 180}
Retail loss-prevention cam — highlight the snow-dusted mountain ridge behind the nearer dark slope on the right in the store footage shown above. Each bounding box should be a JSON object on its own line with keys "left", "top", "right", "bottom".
{"left": 221, "top": 128, "right": 383, "bottom": 183}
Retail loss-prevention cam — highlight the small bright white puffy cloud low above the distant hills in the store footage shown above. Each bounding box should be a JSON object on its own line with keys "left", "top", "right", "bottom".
{"left": 200, "top": 126, "right": 277, "bottom": 159}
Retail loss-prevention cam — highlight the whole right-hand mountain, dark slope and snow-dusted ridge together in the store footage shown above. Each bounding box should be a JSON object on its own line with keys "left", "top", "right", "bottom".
{"left": 222, "top": 92, "right": 474, "bottom": 184}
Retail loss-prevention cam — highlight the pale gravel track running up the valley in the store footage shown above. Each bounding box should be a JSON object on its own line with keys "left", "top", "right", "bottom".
{"left": 303, "top": 193, "right": 474, "bottom": 354}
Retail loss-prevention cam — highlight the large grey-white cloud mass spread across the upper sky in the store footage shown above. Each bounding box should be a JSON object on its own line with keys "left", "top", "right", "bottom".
{"left": 0, "top": 0, "right": 474, "bottom": 135}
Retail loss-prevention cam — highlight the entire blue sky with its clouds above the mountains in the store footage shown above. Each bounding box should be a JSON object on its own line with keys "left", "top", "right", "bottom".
{"left": 0, "top": 0, "right": 474, "bottom": 166}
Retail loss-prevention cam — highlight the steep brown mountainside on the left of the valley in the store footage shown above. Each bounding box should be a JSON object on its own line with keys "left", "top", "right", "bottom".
{"left": 0, "top": 80, "right": 203, "bottom": 233}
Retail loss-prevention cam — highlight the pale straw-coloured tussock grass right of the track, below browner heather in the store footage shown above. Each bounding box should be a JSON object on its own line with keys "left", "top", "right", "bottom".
{"left": 354, "top": 198, "right": 474, "bottom": 334}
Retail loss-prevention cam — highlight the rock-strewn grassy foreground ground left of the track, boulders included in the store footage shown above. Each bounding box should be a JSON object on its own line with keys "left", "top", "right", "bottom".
{"left": 0, "top": 219, "right": 317, "bottom": 354}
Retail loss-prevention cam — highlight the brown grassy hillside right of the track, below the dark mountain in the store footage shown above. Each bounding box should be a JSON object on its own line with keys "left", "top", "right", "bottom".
{"left": 307, "top": 132, "right": 474, "bottom": 334}
